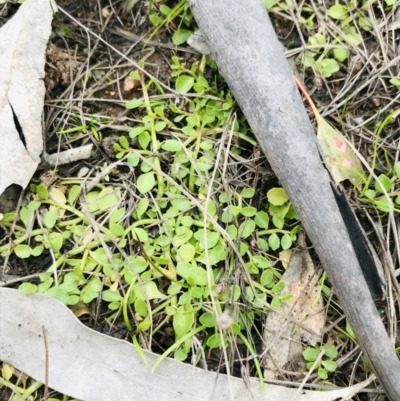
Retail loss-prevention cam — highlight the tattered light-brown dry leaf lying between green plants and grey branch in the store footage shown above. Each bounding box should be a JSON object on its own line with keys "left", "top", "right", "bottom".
{"left": 263, "top": 239, "right": 325, "bottom": 379}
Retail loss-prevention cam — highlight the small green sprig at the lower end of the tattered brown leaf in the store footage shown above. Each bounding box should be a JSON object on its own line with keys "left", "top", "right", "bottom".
{"left": 303, "top": 344, "right": 338, "bottom": 380}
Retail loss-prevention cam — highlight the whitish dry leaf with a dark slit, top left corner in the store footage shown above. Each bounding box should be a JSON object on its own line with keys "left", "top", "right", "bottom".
{"left": 0, "top": 0, "right": 55, "bottom": 194}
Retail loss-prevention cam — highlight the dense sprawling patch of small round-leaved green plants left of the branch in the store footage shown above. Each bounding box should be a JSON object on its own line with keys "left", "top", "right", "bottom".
{"left": 0, "top": 2, "right": 300, "bottom": 384}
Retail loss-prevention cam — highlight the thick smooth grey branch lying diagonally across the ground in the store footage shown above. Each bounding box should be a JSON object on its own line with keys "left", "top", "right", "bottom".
{"left": 188, "top": 0, "right": 400, "bottom": 401}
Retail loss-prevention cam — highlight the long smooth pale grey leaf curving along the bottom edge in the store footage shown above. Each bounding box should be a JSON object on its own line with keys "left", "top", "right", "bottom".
{"left": 0, "top": 288, "right": 376, "bottom": 401}
